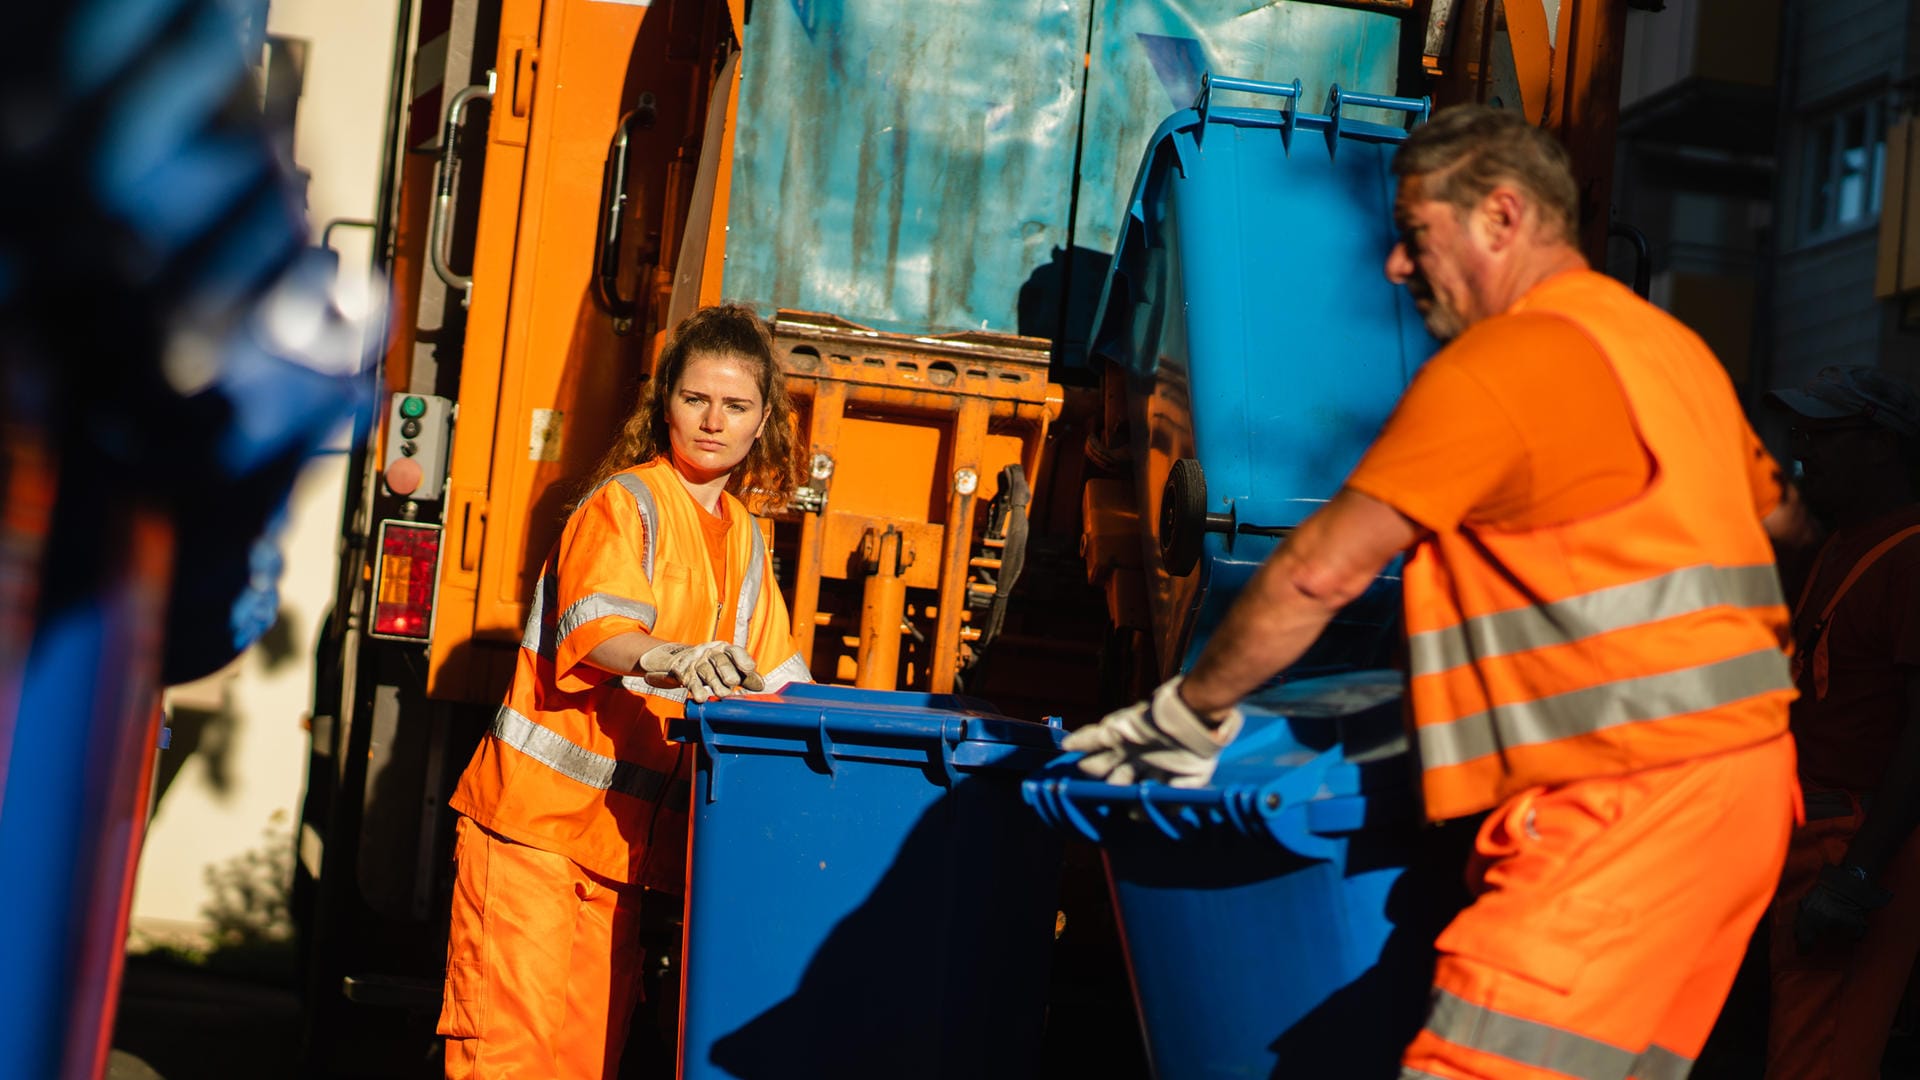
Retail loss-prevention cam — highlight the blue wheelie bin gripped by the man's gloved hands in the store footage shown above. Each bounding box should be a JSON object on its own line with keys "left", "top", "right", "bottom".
{"left": 1025, "top": 671, "right": 1465, "bottom": 1080}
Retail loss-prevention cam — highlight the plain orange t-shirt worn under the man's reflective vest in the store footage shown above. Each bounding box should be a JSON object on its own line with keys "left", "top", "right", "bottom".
{"left": 1346, "top": 311, "right": 1780, "bottom": 532}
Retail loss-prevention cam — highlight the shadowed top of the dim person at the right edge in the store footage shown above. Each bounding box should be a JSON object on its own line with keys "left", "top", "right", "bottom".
{"left": 1791, "top": 505, "right": 1920, "bottom": 796}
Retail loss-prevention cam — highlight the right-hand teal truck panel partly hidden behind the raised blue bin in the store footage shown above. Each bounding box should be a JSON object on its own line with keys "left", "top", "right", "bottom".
{"left": 1073, "top": 0, "right": 1400, "bottom": 276}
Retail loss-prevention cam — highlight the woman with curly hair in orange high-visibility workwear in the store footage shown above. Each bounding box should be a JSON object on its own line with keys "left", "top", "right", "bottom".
{"left": 440, "top": 307, "right": 810, "bottom": 1080}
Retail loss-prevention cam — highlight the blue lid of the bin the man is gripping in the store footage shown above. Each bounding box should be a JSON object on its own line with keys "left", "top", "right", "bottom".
{"left": 1021, "top": 671, "right": 1419, "bottom": 859}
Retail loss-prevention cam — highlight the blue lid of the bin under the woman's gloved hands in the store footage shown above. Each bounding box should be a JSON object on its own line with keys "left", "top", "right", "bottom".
{"left": 668, "top": 682, "right": 1066, "bottom": 782}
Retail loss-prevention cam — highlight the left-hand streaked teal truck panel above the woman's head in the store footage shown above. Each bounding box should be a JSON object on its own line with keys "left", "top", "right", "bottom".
{"left": 722, "top": 0, "right": 1090, "bottom": 332}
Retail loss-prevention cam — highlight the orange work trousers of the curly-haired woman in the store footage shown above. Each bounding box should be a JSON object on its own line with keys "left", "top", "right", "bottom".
{"left": 440, "top": 817, "right": 641, "bottom": 1080}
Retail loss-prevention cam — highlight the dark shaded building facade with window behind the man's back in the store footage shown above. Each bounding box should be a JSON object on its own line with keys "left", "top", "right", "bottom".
{"left": 1611, "top": 0, "right": 1920, "bottom": 428}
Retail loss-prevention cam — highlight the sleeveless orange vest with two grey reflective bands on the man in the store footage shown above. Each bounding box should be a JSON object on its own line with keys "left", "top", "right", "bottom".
{"left": 1404, "top": 273, "right": 1793, "bottom": 821}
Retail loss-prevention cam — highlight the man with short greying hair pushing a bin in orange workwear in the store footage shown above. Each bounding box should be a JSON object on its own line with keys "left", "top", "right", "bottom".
{"left": 1066, "top": 106, "right": 1799, "bottom": 1080}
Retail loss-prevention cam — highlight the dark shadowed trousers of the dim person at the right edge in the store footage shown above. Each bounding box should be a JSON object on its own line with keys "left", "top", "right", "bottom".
{"left": 1766, "top": 780, "right": 1920, "bottom": 1080}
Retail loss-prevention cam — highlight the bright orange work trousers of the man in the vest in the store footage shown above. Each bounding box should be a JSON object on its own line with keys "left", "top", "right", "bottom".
{"left": 1402, "top": 736, "right": 1799, "bottom": 1080}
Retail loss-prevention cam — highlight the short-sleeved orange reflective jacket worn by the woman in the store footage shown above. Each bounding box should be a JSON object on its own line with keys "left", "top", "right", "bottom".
{"left": 453, "top": 459, "right": 810, "bottom": 890}
